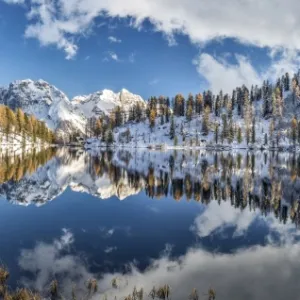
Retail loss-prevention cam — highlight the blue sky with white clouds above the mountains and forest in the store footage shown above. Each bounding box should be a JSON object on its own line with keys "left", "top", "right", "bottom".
{"left": 0, "top": 0, "right": 300, "bottom": 98}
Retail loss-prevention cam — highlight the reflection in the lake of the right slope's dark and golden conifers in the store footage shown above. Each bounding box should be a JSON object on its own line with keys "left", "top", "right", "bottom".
{"left": 90, "top": 151, "right": 300, "bottom": 225}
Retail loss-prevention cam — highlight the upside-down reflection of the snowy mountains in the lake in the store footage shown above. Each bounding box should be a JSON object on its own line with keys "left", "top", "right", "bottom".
{"left": 0, "top": 148, "right": 142, "bottom": 206}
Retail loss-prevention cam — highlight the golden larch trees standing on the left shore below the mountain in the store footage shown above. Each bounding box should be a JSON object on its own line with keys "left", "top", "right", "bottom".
{"left": 0, "top": 105, "right": 55, "bottom": 144}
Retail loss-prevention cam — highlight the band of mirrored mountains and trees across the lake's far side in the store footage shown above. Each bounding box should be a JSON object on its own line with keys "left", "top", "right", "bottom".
{"left": 0, "top": 149, "right": 300, "bottom": 224}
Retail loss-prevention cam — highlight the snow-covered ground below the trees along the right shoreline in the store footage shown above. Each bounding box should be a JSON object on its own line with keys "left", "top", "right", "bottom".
{"left": 85, "top": 114, "right": 293, "bottom": 150}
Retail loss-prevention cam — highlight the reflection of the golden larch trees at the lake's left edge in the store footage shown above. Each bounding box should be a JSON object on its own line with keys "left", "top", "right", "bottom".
{"left": 0, "top": 148, "right": 56, "bottom": 183}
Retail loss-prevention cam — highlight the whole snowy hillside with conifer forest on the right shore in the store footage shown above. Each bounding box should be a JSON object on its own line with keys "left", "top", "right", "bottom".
{"left": 86, "top": 72, "right": 300, "bottom": 148}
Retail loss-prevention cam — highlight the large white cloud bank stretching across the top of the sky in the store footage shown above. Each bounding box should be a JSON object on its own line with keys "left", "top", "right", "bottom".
{"left": 4, "top": 0, "right": 300, "bottom": 57}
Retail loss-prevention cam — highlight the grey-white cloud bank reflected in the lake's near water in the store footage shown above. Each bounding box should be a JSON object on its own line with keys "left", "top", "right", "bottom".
{"left": 18, "top": 225, "right": 300, "bottom": 300}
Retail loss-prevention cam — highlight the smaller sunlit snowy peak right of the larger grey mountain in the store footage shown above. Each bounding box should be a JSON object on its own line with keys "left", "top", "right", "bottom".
{"left": 72, "top": 89, "right": 146, "bottom": 118}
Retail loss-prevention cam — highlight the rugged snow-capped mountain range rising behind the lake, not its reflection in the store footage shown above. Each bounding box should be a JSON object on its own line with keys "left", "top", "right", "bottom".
{"left": 0, "top": 79, "right": 145, "bottom": 141}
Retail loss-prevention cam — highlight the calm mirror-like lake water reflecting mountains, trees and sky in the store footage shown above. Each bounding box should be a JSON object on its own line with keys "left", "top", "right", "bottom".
{"left": 0, "top": 149, "right": 300, "bottom": 300}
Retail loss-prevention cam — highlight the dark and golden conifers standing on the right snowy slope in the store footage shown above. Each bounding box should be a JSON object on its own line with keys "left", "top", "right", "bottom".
{"left": 87, "top": 71, "right": 300, "bottom": 146}
